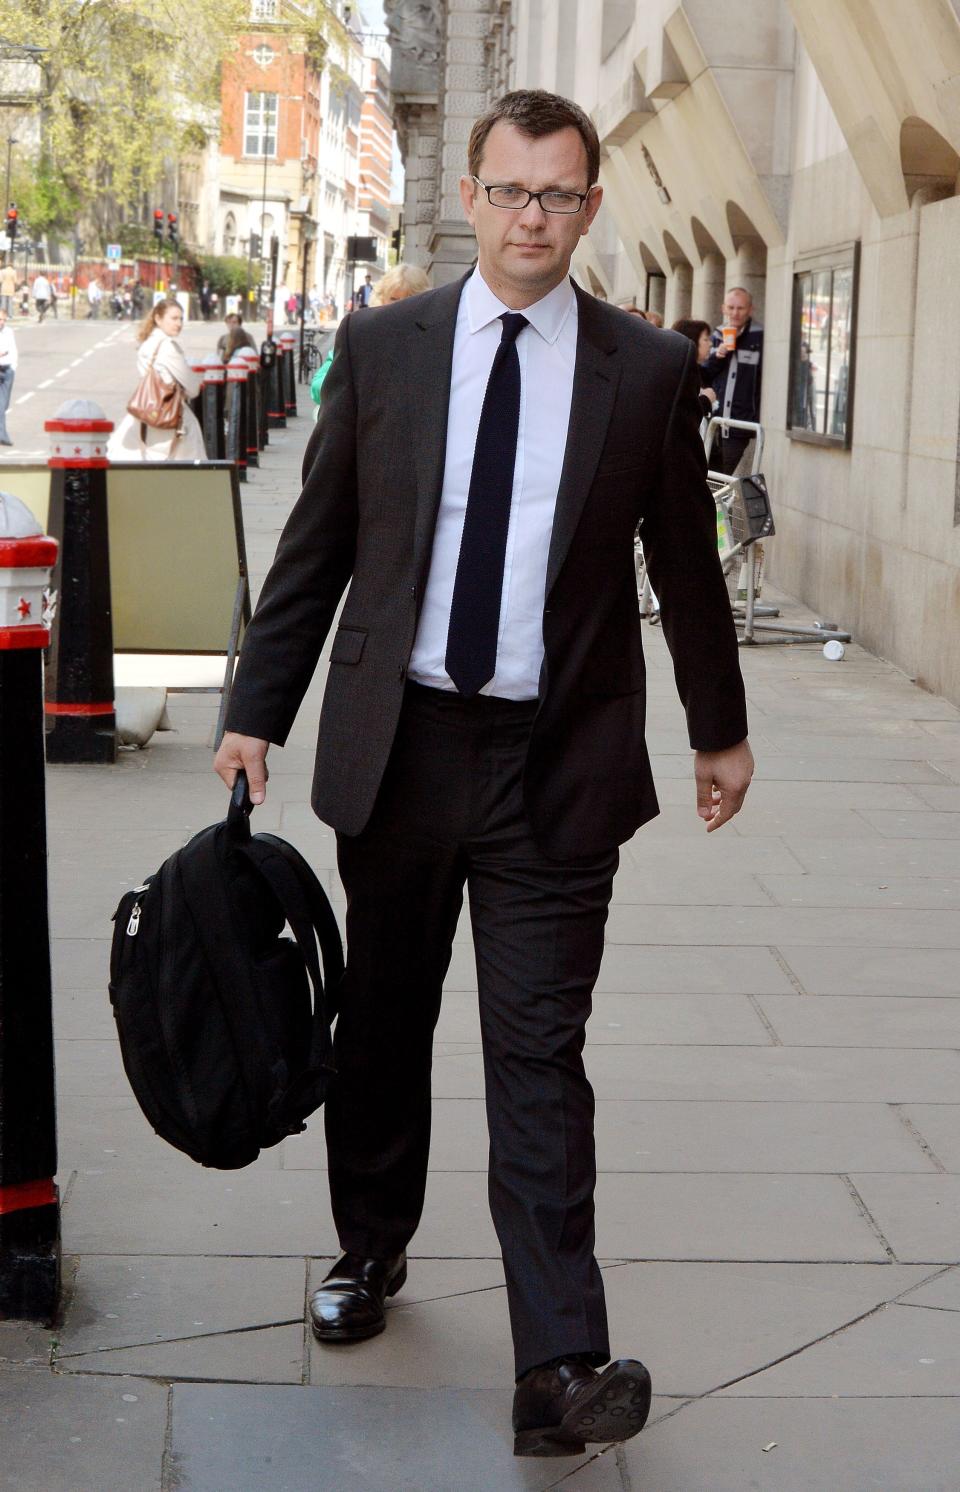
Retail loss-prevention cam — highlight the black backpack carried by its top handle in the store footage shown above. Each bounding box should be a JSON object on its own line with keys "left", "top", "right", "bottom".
{"left": 110, "top": 773, "right": 343, "bottom": 1170}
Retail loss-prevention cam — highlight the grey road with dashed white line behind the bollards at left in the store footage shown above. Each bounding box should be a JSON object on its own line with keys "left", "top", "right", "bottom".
{"left": 3, "top": 316, "right": 266, "bottom": 463}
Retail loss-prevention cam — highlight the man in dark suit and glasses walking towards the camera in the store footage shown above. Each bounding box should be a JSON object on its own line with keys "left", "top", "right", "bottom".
{"left": 216, "top": 91, "right": 752, "bottom": 1455}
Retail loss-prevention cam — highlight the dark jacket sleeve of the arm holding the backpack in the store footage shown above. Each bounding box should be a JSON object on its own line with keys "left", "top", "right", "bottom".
{"left": 227, "top": 318, "right": 357, "bottom": 746}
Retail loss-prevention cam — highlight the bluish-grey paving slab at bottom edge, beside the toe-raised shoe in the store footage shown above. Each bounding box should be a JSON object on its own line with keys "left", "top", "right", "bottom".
{"left": 163, "top": 1383, "right": 623, "bottom": 1492}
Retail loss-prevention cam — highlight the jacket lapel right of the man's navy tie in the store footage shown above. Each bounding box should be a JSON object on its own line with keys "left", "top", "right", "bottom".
{"left": 546, "top": 285, "right": 620, "bottom": 595}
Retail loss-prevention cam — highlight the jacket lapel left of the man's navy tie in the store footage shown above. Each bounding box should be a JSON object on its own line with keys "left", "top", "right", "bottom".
{"left": 406, "top": 276, "right": 469, "bottom": 579}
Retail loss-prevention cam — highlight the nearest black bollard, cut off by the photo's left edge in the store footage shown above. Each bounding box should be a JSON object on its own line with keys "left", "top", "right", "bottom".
{"left": 0, "top": 495, "right": 60, "bottom": 1323}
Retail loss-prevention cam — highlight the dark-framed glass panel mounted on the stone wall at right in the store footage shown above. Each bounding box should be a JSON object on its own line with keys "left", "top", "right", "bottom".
{"left": 787, "top": 243, "right": 860, "bottom": 448}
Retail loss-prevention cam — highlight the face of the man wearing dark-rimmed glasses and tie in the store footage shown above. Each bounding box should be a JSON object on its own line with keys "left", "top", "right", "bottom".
{"left": 460, "top": 119, "right": 603, "bottom": 309}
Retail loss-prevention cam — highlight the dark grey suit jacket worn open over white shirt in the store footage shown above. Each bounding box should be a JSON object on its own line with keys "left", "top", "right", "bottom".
{"left": 227, "top": 282, "right": 747, "bottom": 858}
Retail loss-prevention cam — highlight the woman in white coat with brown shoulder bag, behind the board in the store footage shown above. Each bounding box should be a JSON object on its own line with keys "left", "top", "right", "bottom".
{"left": 106, "top": 300, "right": 206, "bottom": 461}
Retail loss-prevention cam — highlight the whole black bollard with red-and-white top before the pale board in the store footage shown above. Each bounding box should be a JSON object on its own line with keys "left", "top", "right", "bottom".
{"left": 43, "top": 398, "right": 116, "bottom": 762}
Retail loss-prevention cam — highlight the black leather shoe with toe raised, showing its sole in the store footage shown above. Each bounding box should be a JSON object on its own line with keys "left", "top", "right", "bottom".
{"left": 514, "top": 1358, "right": 651, "bottom": 1456}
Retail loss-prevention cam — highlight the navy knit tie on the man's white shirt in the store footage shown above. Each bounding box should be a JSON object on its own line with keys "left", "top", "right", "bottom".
{"left": 443, "top": 310, "right": 527, "bottom": 698}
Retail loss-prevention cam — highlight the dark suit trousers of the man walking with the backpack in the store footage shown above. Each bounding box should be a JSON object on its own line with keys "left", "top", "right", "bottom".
{"left": 325, "top": 685, "right": 618, "bottom": 1374}
